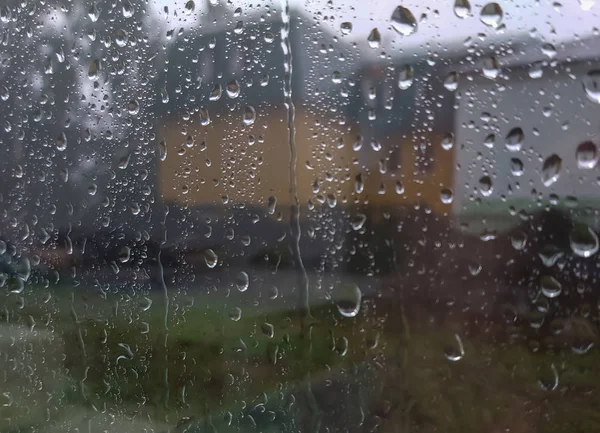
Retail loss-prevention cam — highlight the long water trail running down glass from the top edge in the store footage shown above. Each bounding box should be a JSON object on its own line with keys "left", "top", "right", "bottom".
{"left": 281, "top": 0, "right": 310, "bottom": 324}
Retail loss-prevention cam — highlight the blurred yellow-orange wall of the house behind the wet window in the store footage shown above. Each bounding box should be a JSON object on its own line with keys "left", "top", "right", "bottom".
{"left": 158, "top": 105, "right": 454, "bottom": 213}
